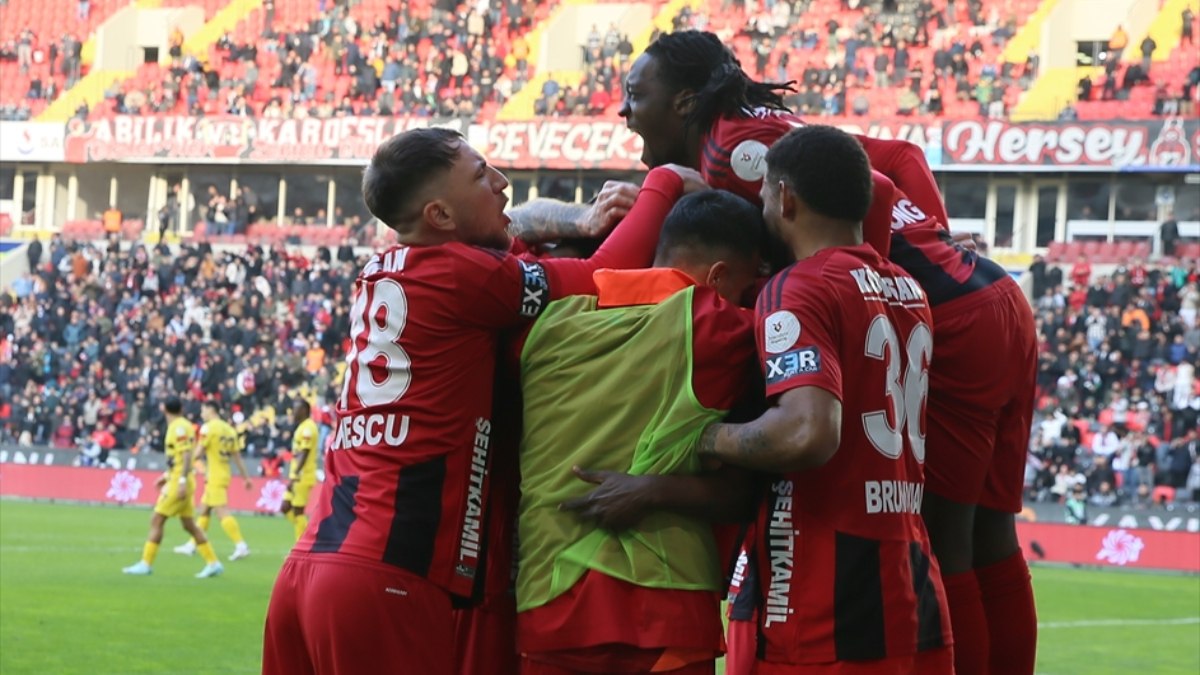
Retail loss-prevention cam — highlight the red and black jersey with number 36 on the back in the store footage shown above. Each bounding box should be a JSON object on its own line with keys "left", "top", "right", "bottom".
{"left": 756, "top": 245, "right": 950, "bottom": 663}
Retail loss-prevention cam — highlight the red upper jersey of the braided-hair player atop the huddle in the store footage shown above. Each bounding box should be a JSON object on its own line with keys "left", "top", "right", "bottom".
{"left": 700, "top": 108, "right": 949, "bottom": 225}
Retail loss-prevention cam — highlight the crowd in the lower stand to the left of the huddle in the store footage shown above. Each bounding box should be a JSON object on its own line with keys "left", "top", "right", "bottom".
{"left": 0, "top": 230, "right": 365, "bottom": 468}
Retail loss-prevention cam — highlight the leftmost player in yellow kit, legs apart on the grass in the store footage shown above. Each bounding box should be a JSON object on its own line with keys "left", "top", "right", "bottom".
{"left": 121, "top": 398, "right": 224, "bottom": 579}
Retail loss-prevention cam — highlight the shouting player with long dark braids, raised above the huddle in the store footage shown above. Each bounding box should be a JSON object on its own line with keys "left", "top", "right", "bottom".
{"left": 620, "top": 31, "right": 1037, "bottom": 675}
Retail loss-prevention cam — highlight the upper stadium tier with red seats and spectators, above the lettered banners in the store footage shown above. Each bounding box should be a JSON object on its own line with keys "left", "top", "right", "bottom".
{"left": 0, "top": 0, "right": 1200, "bottom": 119}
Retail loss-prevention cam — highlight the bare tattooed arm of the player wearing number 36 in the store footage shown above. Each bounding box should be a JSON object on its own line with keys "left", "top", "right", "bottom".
{"left": 700, "top": 387, "right": 841, "bottom": 473}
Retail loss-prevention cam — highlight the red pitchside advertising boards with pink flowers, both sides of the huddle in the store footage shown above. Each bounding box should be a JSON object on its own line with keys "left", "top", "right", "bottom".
{"left": 0, "top": 447, "right": 1200, "bottom": 573}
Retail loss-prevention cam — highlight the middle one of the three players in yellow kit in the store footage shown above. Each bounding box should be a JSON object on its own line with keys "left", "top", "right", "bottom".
{"left": 174, "top": 401, "right": 254, "bottom": 561}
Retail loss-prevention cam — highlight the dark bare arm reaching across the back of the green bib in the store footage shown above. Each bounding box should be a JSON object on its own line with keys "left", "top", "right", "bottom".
{"left": 559, "top": 466, "right": 755, "bottom": 531}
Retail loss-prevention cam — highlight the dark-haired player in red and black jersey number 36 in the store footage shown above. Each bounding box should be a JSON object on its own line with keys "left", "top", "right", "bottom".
{"left": 701, "top": 126, "right": 953, "bottom": 675}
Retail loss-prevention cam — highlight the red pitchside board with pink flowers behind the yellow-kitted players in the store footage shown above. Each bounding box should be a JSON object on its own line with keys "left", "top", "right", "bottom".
{"left": 0, "top": 464, "right": 323, "bottom": 513}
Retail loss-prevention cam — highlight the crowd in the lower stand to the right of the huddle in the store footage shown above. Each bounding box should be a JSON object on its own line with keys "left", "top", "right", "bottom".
{"left": 1026, "top": 257, "right": 1200, "bottom": 511}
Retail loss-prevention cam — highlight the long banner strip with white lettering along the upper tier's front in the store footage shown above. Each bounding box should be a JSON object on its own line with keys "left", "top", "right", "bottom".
{"left": 0, "top": 115, "right": 1200, "bottom": 172}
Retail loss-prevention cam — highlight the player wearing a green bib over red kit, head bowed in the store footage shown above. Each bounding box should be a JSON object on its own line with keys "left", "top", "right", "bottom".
{"left": 517, "top": 190, "right": 763, "bottom": 675}
